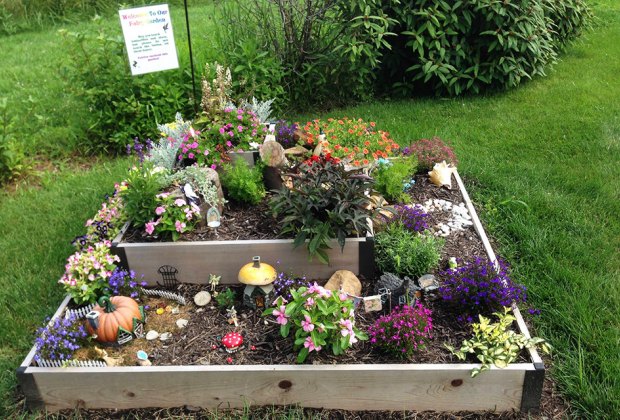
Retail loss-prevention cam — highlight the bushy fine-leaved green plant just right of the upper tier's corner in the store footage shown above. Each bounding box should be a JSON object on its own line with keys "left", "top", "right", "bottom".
{"left": 375, "top": 223, "right": 444, "bottom": 278}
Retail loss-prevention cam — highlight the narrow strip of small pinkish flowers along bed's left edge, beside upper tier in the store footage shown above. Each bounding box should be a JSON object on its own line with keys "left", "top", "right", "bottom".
{"left": 72, "top": 182, "right": 127, "bottom": 251}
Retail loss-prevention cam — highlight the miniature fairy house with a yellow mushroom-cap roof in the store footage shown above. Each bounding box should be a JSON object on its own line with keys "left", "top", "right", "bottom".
{"left": 239, "top": 257, "right": 277, "bottom": 309}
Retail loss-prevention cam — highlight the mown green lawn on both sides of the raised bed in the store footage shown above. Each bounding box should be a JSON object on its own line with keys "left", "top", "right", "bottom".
{"left": 0, "top": 0, "right": 620, "bottom": 418}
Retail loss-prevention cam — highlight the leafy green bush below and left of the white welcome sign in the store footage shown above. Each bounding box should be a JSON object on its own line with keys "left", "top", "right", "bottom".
{"left": 61, "top": 23, "right": 192, "bottom": 153}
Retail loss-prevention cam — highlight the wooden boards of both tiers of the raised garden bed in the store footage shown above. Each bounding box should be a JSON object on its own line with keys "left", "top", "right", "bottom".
{"left": 18, "top": 173, "right": 545, "bottom": 411}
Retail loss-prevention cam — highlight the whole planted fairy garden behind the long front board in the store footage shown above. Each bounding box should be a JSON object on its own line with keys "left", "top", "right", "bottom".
{"left": 26, "top": 66, "right": 548, "bottom": 410}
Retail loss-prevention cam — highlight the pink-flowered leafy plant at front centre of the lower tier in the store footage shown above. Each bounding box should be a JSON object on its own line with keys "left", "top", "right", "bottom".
{"left": 263, "top": 283, "right": 368, "bottom": 363}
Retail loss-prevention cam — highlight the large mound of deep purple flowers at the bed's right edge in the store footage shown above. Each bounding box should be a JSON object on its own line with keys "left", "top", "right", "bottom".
{"left": 439, "top": 257, "right": 527, "bottom": 323}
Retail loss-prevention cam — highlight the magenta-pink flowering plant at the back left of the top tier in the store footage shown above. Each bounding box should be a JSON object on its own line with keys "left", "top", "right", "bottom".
{"left": 177, "top": 108, "right": 267, "bottom": 169}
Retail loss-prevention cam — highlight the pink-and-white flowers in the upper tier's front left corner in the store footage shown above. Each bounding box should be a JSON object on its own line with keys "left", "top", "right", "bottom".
{"left": 144, "top": 193, "right": 200, "bottom": 241}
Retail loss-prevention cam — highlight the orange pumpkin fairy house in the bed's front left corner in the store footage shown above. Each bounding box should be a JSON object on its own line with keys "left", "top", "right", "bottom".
{"left": 86, "top": 296, "right": 142, "bottom": 343}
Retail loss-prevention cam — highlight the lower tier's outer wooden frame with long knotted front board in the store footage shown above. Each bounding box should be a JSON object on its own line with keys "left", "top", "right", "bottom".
{"left": 17, "top": 173, "right": 545, "bottom": 411}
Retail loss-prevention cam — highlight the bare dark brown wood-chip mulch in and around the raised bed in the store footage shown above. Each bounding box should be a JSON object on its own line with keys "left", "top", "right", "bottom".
{"left": 18, "top": 172, "right": 568, "bottom": 419}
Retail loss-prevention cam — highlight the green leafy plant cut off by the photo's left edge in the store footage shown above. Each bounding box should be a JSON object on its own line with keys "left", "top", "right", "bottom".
{"left": 0, "top": 98, "right": 26, "bottom": 185}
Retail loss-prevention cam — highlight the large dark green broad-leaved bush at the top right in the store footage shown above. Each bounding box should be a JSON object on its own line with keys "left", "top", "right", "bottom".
{"left": 381, "top": 0, "right": 590, "bottom": 95}
